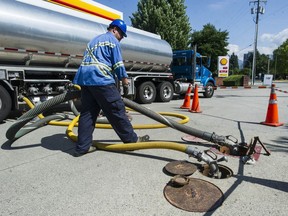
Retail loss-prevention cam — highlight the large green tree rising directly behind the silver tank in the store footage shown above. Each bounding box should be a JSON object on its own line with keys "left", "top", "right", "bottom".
{"left": 130, "top": 0, "right": 191, "bottom": 50}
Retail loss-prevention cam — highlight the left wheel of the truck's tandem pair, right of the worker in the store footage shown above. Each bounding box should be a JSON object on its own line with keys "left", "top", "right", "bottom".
{"left": 136, "top": 81, "right": 156, "bottom": 104}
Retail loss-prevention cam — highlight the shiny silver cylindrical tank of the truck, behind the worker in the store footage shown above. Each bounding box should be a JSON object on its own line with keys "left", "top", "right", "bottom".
{"left": 0, "top": 0, "right": 172, "bottom": 72}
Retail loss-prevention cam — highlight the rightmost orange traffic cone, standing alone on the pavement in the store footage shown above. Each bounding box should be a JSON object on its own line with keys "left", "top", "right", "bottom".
{"left": 261, "top": 84, "right": 283, "bottom": 127}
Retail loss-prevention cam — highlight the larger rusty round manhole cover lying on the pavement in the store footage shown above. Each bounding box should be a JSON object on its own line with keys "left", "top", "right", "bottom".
{"left": 164, "top": 178, "right": 224, "bottom": 212}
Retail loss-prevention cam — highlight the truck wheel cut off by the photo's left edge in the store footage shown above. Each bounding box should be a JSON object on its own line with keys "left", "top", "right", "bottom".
{"left": 0, "top": 85, "right": 12, "bottom": 122}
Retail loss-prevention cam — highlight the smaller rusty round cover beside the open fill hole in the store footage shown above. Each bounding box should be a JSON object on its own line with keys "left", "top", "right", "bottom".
{"left": 165, "top": 161, "right": 197, "bottom": 176}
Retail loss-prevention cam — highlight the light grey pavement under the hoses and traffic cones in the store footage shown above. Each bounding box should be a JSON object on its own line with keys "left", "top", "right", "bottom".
{"left": 0, "top": 82, "right": 288, "bottom": 216}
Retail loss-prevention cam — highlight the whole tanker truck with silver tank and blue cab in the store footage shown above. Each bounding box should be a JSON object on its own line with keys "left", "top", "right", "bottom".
{"left": 0, "top": 0, "right": 215, "bottom": 122}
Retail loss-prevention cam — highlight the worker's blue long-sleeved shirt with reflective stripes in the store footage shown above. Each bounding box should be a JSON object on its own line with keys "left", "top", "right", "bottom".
{"left": 73, "top": 32, "right": 128, "bottom": 86}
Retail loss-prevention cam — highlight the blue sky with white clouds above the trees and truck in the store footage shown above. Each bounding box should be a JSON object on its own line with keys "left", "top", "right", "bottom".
{"left": 95, "top": 0, "right": 288, "bottom": 60}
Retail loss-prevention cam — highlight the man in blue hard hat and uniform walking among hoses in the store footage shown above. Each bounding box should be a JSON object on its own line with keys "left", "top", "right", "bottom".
{"left": 73, "top": 19, "right": 149, "bottom": 157}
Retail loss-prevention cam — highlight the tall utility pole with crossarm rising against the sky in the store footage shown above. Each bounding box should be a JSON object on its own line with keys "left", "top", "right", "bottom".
{"left": 249, "top": 0, "right": 267, "bottom": 85}
